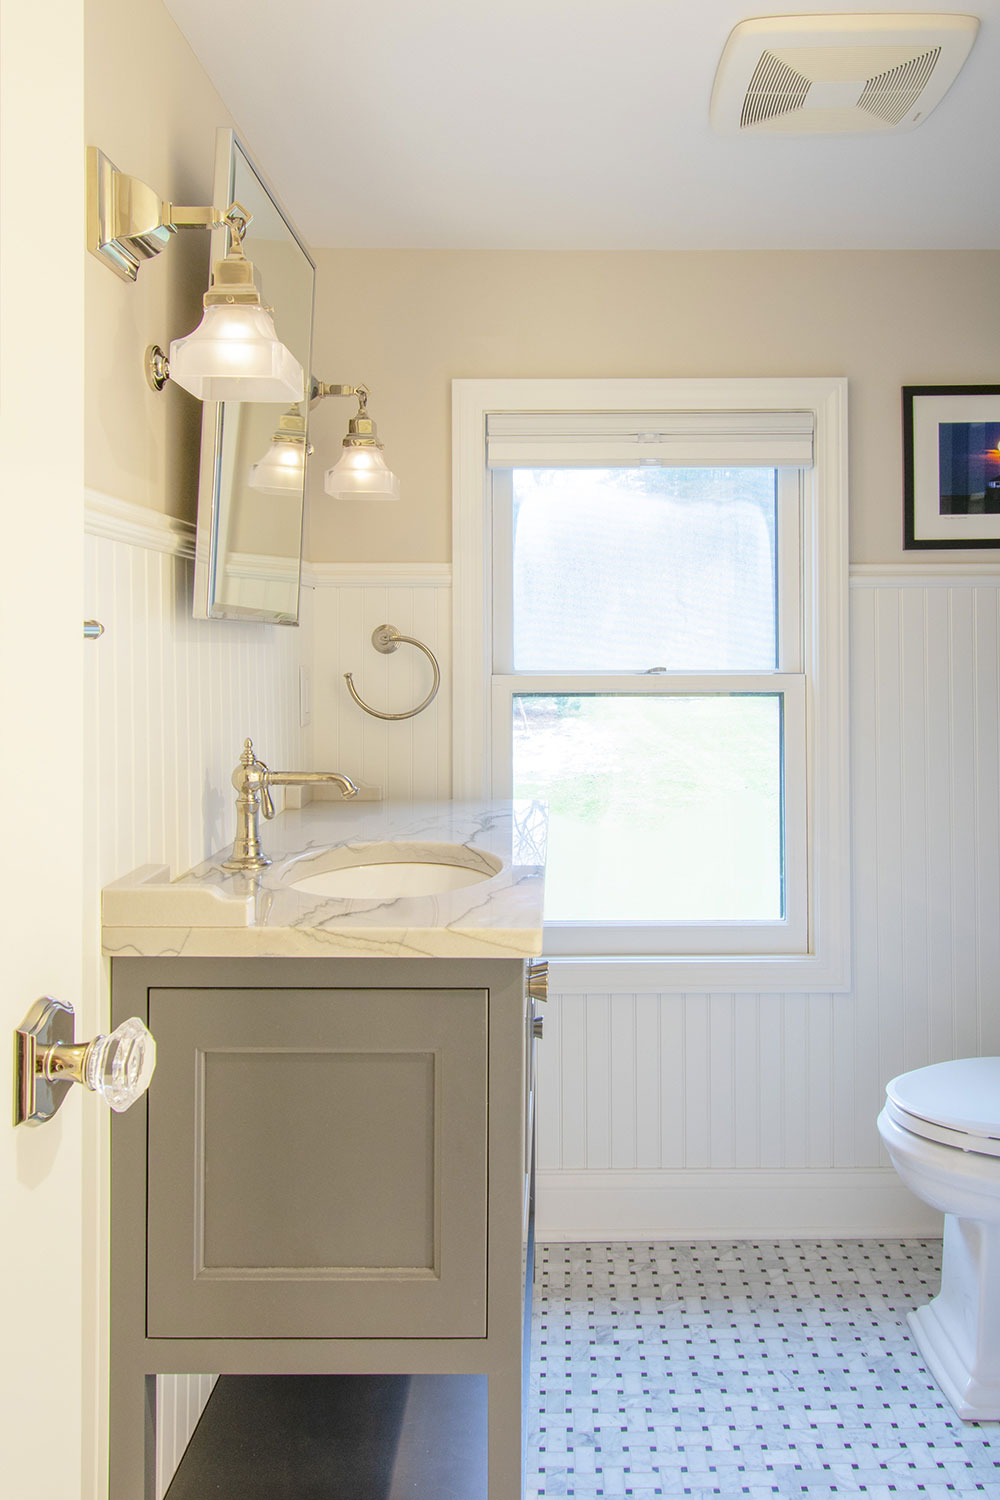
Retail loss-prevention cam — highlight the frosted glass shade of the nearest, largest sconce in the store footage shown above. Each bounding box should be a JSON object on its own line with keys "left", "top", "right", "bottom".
{"left": 169, "top": 303, "right": 306, "bottom": 402}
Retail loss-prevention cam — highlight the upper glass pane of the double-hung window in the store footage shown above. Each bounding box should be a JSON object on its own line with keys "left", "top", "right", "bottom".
{"left": 513, "top": 468, "right": 778, "bottom": 672}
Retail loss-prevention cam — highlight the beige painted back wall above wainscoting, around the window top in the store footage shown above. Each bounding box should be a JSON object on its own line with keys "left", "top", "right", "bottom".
{"left": 307, "top": 251, "right": 1000, "bottom": 563}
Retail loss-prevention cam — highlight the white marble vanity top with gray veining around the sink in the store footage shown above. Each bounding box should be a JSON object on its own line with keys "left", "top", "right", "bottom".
{"left": 102, "top": 801, "right": 546, "bottom": 959}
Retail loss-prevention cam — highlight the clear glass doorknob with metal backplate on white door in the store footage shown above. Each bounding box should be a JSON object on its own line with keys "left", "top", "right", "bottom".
{"left": 13, "top": 995, "right": 156, "bottom": 1125}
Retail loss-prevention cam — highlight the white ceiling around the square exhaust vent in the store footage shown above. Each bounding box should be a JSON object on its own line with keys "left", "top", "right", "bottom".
{"left": 166, "top": 0, "right": 1000, "bottom": 249}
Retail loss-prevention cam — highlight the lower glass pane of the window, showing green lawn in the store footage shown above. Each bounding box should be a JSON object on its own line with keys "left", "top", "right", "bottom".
{"left": 513, "top": 693, "right": 784, "bottom": 923}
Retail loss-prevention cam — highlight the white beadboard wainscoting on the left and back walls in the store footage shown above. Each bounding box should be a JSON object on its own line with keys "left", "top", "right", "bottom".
{"left": 81, "top": 549, "right": 1000, "bottom": 1476}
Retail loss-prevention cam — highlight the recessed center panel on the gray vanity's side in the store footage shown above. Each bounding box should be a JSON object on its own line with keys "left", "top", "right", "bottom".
{"left": 195, "top": 1050, "right": 436, "bottom": 1275}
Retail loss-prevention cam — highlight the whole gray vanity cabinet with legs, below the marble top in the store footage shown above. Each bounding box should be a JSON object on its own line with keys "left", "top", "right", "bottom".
{"left": 111, "top": 957, "right": 532, "bottom": 1500}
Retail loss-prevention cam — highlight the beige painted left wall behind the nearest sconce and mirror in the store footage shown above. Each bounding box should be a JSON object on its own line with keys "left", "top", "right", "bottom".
{"left": 84, "top": 0, "right": 234, "bottom": 521}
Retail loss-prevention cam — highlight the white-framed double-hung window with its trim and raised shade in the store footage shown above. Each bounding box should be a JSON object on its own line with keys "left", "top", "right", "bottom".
{"left": 454, "top": 381, "right": 847, "bottom": 989}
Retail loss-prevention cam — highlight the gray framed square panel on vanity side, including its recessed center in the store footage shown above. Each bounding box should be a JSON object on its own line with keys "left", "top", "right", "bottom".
{"left": 147, "top": 989, "right": 487, "bottom": 1338}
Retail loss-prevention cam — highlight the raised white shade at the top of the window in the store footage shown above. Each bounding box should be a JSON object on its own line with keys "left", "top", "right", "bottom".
{"left": 486, "top": 411, "right": 813, "bottom": 468}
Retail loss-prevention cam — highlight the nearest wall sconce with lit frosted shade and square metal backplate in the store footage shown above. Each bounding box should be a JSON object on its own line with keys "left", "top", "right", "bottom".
{"left": 87, "top": 146, "right": 306, "bottom": 402}
